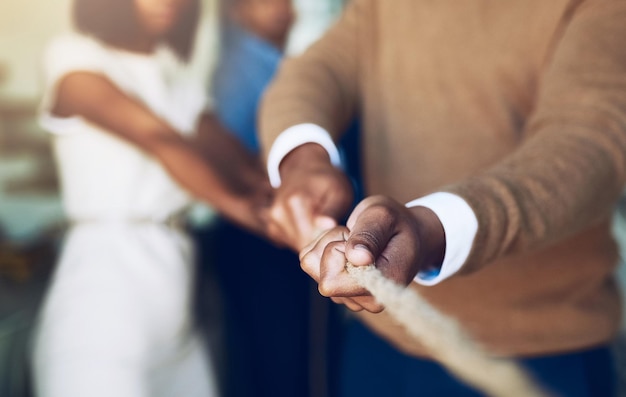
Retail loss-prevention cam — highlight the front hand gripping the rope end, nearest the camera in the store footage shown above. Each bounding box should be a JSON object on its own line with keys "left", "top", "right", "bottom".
{"left": 300, "top": 196, "right": 445, "bottom": 313}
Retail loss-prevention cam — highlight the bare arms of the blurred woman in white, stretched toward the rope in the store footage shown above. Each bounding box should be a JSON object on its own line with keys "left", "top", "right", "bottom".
{"left": 53, "top": 72, "right": 271, "bottom": 233}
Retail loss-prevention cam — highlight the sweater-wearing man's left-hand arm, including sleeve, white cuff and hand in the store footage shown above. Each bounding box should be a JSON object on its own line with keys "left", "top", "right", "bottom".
{"left": 260, "top": 0, "right": 371, "bottom": 250}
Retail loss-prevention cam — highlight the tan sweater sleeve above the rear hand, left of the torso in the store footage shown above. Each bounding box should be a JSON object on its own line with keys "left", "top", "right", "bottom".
{"left": 259, "top": 0, "right": 371, "bottom": 162}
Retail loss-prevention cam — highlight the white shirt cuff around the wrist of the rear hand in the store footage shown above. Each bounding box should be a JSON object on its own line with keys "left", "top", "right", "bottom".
{"left": 267, "top": 123, "right": 341, "bottom": 188}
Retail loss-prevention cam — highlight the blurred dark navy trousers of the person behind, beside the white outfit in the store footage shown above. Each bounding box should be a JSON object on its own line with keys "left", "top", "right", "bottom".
{"left": 196, "top": 220, "right": 339, "bottom": 397}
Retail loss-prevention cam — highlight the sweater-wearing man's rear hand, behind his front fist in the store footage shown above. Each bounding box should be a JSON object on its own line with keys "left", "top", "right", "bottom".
{"left": 267, "top": 144, "right": 353, "bottom": 251}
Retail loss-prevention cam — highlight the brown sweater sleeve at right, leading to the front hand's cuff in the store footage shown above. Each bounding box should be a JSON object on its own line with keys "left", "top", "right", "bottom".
{"left": 445, "top": 0, "right": 626, "bottom": 273}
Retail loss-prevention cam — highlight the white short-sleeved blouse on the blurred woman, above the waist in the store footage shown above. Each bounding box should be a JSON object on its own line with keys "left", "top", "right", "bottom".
{"left": 40, "top": 34, "right": 208, "bottom": 222}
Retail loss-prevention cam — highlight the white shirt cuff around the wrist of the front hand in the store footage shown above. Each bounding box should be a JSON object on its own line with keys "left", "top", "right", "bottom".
{"left": 406, "top": 192, "right": 478, "bottom": 286}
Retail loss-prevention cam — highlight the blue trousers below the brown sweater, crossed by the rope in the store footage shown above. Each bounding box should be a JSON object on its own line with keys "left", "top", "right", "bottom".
{"left": 339, "top": 320, "right": 616, "bottom": 397}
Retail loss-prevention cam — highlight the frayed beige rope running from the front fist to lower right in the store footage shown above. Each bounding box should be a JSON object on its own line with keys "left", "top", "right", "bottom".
{"left": 346, "top": 263, "right": 548, "bottom": 397}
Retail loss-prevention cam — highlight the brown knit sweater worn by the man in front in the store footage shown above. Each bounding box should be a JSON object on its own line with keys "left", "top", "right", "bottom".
{"left": 260, "top": 0, "right": 626, "bottom": 355}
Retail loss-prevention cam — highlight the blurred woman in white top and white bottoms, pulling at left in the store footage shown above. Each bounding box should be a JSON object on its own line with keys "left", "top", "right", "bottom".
{"left": 33, "top": 0, "right": 271, "bottom": 397}
